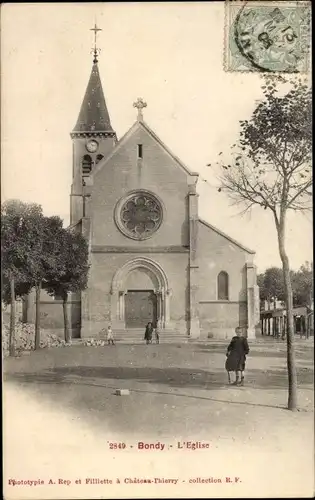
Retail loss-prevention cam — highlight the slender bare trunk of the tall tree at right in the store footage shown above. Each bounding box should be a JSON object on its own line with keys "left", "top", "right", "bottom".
{"left": 277, "top": 222, "right": 297, "bottom": 411}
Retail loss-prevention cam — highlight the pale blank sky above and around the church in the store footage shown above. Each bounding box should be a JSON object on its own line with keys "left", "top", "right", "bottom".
{"left": 1, "top": 2, "right": 312, "bottom": 272}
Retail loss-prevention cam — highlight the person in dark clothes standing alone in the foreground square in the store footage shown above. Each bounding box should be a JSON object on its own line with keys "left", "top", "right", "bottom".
{"left": 225, "top": 327, "right": 249, "bottom": 385}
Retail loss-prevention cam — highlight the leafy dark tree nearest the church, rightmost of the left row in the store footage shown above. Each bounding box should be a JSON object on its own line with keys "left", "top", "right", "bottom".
{"left": 44, "top": 229, "right": 89, "bottom": 342}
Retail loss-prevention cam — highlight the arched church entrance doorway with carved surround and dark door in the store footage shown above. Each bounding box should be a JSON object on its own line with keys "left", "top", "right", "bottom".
{"left": 111, "top": 257, "right": 171, "bottom": 329}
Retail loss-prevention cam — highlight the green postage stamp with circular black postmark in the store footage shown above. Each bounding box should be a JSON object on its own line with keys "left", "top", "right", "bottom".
{"left": 225, "top": 0, "right": 311, "bottom": 73}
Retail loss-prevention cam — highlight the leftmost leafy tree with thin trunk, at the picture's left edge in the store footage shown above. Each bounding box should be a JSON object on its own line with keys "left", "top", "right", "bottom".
{"left": 1, "top": 200, "right": 43, "bottom": 356}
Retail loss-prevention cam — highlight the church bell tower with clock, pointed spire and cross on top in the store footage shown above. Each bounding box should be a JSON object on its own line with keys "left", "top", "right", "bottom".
{"left": 70, "top": 24, "right": 117, "bottom": 224}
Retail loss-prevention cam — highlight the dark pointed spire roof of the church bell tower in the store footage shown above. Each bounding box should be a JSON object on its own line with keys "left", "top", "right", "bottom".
{"left": 73, "top": 62, "right": 115, "bottom": 135}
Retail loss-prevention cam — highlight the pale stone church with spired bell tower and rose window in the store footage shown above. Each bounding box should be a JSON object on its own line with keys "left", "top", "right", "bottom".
{"left": 30, "top": 33, "right": 259, "bottom": 342}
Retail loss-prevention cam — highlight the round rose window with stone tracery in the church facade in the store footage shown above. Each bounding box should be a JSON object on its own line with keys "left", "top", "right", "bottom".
{"left": 119, "top": 193, "right": 162, "bottom": 240}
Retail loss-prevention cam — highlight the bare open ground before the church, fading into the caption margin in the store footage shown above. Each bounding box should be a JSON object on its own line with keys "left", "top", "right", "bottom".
{"left": 4, "top": 343, "right": 313, "bottom": 435}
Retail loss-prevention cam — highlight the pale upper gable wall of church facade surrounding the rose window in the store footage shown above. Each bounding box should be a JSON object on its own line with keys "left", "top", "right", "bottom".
{"left": 89, "top": 122, "right": 196, "bottom": 248}
